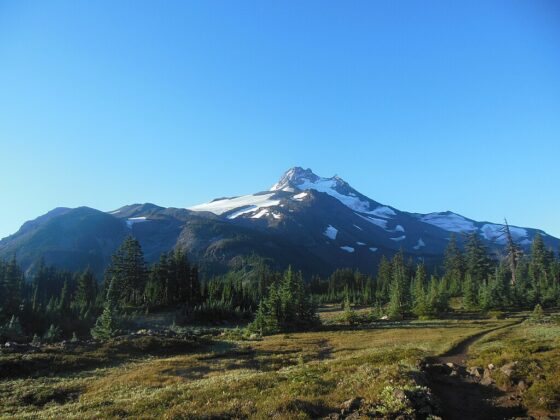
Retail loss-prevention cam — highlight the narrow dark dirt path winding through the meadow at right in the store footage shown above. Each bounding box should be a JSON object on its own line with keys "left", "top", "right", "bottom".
{"left": 426, "top": 319, "right": 527, "bottom": 420}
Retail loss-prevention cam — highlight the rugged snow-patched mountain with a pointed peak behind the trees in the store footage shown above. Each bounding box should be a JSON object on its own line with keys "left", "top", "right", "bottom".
{"left": 0, "top": 167, "right": 560, "bottom": 274}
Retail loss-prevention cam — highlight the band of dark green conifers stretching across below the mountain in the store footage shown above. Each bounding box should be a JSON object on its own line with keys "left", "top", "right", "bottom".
{"left": 0, "top": 231, "right": 560, "bottom": 341}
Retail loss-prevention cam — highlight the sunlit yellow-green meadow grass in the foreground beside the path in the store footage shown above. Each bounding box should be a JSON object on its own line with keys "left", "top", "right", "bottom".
{"left": 0, "top": 310, "right": 559, "bottom": 419}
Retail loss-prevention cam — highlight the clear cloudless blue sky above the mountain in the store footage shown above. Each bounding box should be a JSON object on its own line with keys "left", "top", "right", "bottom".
{"left": 0, "top": 0, "right": 560, "bottom": 237}
